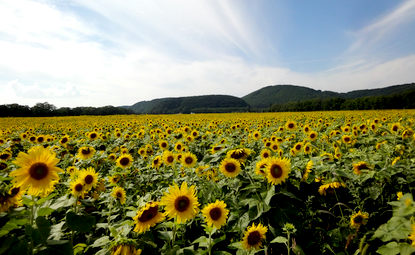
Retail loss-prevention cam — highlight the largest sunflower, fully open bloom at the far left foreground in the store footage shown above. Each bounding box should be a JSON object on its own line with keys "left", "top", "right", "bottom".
{"left": 10, "top": 146, "right": 62, "bottom": 196}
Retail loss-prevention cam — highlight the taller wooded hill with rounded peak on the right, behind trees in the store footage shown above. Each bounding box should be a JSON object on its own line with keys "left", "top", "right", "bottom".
{"left": 242, "top": 83, "right": 415, "bottom": 110}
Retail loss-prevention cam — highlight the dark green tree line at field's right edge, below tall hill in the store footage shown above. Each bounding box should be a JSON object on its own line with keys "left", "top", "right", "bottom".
{"left": 269, "top": 90, "right": 415, "bottom": 112}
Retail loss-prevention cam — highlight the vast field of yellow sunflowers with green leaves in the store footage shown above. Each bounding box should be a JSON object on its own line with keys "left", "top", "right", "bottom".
{"left": 0, "top": 110, "right": 415, "bottom": 254}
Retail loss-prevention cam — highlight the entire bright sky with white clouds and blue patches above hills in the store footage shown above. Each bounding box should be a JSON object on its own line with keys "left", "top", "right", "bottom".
{"left": 0, "top": 0, "right": 415, "bottom": 107}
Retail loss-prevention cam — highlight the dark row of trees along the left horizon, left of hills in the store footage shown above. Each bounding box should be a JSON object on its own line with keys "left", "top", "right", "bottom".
{"left": 0, "top": 102, "right": 133, "bottom": 117}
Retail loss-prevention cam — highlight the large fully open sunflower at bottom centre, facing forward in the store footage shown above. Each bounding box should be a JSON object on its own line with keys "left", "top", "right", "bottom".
{"left": 160, "top": 182, "right": 199, "bottom": 224}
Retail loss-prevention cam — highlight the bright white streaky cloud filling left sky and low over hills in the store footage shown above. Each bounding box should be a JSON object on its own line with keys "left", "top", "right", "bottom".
{"left": 0, "top": 0, "right": 415, "bottom": 107}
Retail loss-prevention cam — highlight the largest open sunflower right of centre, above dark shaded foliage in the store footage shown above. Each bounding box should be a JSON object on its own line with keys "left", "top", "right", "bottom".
{"left": 266, "top": 157, "right": 291, "bottom": 185}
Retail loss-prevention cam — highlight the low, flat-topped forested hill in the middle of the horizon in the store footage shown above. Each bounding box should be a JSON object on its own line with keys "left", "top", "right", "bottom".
{"left": 125, "top": 95, "right": 249, "bottom": 114}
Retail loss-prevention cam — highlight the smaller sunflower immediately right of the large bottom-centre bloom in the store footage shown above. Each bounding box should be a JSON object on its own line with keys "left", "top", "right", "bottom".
{"left": 202, "top": 200, "right": 229, "bottom": 229}
